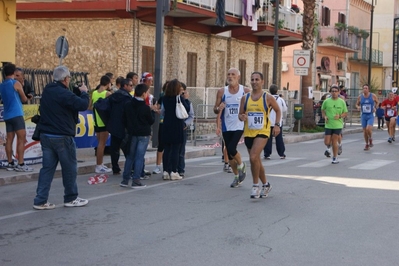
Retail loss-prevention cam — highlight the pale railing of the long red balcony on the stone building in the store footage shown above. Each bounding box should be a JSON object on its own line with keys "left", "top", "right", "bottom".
{"left": 173, "top": 0, "right": 303, "bottom": 32}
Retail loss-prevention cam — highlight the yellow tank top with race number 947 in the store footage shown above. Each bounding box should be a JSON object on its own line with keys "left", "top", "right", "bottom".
{"left": 244, "top": 92, "right": 270, "bottom": 138}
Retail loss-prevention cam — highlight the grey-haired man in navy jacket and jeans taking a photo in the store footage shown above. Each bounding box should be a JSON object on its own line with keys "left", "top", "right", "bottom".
{"left": 33, "top": 66, "right": 89, "bottom": 210}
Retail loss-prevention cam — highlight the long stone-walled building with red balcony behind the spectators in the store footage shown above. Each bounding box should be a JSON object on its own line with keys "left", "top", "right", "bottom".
{"left": 15, "top": 0, "right": 302, "bottom": 90}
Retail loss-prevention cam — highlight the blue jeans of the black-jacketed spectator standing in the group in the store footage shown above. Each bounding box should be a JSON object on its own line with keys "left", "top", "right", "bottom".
{"left": 123, "top": 136, "right": 150, "bottom": 180}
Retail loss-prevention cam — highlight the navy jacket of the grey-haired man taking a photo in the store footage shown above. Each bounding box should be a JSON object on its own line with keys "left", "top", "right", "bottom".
{"left": 39, "top": 81, "right": 89, "bottom": 136}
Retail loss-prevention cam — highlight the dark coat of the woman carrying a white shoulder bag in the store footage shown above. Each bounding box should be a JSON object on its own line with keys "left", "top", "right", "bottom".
{"left": 161, "top": 96, "right": 190, "bottom": 144}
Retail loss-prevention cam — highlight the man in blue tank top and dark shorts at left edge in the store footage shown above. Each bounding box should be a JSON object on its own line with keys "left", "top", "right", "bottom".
{"left": 0, "top": 64, "right": 33, "bottom": 172}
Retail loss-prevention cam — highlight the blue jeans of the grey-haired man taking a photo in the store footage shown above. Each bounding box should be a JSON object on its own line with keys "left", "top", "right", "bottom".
{"left": 34, "top": 134, "right": 78, "bottom": 205}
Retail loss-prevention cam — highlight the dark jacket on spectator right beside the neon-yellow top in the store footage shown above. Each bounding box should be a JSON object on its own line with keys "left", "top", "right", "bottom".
{"left": 107, "top": 89, "right": 132, "bottom": 139}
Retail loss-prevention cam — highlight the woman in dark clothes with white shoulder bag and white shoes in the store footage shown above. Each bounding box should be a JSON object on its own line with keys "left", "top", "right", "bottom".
{"left": 161, "top": 79, "right": 190, "bottom": 180}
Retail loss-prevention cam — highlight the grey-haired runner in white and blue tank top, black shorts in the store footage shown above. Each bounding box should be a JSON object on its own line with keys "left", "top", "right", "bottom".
{"left": 213, "top": 68, "right": 252, "bottom": 188}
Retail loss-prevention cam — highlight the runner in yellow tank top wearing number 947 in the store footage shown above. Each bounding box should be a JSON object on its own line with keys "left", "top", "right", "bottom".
{"left": 239, "top": 72, "right": 281, "bottom": 199}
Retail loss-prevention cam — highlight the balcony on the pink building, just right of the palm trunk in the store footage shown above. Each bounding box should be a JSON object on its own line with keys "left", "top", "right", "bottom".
{"left": 318, "top": 27, "right": 362, "bottom": 53}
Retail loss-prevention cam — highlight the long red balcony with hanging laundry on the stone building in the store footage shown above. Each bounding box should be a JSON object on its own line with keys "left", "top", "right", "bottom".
{"left": 135, "top": 0, "right": 302, "bottom": 47}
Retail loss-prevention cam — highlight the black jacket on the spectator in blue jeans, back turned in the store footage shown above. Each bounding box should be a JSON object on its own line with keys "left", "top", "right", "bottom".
{"left": 123, "top": 98, "right": 155, "bottom": 136}
